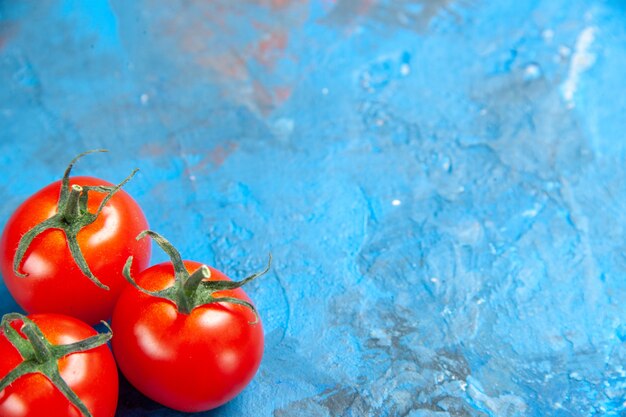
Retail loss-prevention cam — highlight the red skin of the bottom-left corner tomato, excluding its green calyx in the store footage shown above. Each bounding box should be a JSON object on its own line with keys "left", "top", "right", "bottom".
{"left": 0, "top": 314, "right": 118, "bottom": 417}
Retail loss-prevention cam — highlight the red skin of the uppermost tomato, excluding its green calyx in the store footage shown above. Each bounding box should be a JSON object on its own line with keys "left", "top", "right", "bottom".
{"left": 0, "top": 177, "right": 150, "bottom": 324}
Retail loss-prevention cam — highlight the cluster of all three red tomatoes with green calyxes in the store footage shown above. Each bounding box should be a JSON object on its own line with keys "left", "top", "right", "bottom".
{"left": 0, "top": 151, "right": 271, "bottom": 417}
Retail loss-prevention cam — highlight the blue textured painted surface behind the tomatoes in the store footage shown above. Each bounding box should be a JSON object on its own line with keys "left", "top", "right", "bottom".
{"left": 0, "top": 0, "right": 626, "bottom": 417}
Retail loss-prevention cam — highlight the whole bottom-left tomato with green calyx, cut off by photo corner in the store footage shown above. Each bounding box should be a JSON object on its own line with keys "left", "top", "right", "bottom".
{"left": 0, "top": 314, "right": 118, "bottom": 417}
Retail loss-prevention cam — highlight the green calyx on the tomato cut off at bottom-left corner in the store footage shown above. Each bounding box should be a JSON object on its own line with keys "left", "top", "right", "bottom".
{"left": 0, "top": 313, "right": 113, "bottom": 417}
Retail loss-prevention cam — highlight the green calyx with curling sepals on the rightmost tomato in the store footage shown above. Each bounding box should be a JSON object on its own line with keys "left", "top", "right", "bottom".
{"left": 123, "top": 230, "right": 272, "bottom": 324}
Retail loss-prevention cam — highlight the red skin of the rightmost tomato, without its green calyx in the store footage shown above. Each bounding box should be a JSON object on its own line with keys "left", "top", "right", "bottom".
{"left": 112, "top": 261, "right": 264, "bottom": 412}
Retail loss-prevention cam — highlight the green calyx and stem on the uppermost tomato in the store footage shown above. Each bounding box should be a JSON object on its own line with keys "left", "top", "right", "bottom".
{"left": 13, "top": 149, "right": 138, "bottom": 290}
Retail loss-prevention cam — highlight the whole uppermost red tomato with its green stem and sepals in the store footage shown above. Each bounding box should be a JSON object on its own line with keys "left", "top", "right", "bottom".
{"left": 0, "top": 150, "right": 151, "bottom": 324}
